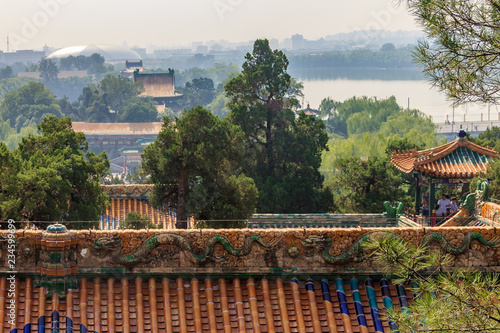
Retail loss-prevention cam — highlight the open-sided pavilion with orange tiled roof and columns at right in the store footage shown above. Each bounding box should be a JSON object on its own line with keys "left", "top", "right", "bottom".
{"left": 391, "top": 131, "right": 498, "bottom": 213}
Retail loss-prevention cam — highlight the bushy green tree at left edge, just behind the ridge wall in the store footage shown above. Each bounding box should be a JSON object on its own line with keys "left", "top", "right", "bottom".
{"left": 0, "top": 116, "right": 109, "bottom": 226}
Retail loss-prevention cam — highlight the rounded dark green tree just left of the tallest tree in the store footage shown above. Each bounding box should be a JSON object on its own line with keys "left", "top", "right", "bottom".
{"left": 142, "top": 106, "right": 256, "bottom": 227}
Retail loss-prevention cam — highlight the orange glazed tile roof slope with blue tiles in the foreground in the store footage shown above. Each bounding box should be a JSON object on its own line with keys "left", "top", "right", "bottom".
{"left": 0, "top": 278, "right": 411, "bottom": 333}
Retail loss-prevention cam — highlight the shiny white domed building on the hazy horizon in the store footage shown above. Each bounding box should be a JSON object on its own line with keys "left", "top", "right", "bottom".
{"left": 47, "top": 44, "right": 141, "bottom": 62}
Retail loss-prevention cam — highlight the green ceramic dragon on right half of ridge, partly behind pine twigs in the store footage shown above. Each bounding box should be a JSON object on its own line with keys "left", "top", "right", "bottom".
{"left": 303, "top": 232, "right": 500, "bottom": 264}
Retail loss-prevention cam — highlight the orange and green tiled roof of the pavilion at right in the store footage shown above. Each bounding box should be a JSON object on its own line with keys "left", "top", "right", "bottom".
{"left": 391, "top": 138, "right": 498, "bottom": 178}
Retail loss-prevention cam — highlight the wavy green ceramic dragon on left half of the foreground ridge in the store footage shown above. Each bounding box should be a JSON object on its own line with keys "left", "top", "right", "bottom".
{"left": 92, "top": 233, "right": 279, "bottom": 266}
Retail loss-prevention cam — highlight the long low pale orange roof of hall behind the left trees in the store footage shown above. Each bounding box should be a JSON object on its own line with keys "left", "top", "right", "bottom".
{"left": 73, "top": 121, "right": 163, "bottom": 135}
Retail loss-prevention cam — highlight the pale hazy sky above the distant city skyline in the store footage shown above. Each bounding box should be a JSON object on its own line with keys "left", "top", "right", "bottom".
{"left": 0, "top": 0, "right": 418, "bottom": 51}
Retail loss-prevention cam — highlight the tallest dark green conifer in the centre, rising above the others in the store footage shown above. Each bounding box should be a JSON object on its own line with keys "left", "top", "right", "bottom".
{"left": 225, "top": 40, "right": 331, "bottom": 213}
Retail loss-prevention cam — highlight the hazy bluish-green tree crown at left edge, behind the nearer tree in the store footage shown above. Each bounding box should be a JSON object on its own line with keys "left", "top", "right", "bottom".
{"left": 0, "top": 82, "right": 63, "bottom": 131}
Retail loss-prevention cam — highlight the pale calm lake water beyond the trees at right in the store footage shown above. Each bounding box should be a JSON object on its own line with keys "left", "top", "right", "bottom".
{"left": 289, "top": 68, "right": 500, "bottom": 123}
